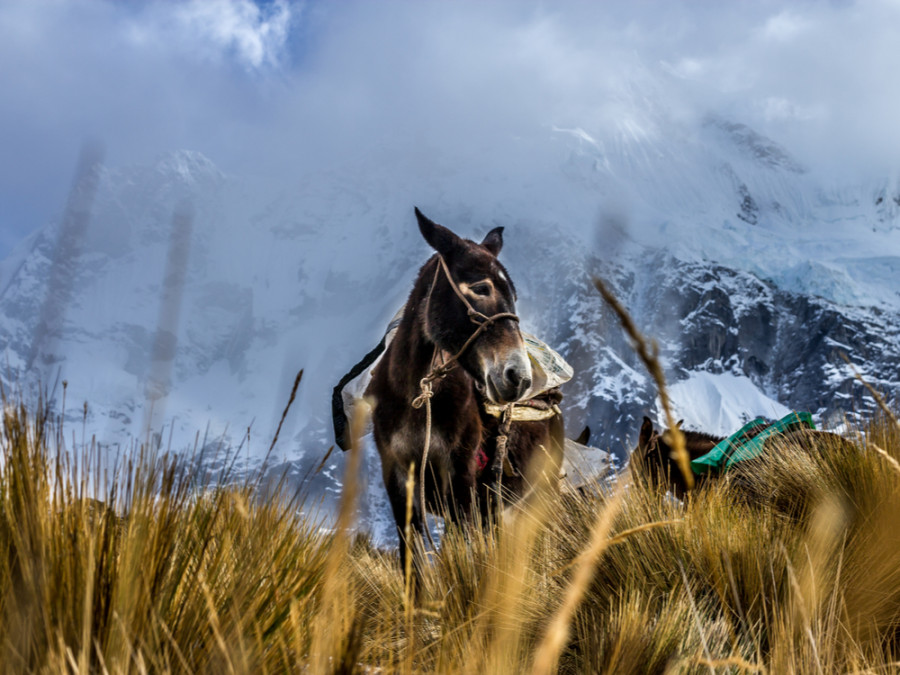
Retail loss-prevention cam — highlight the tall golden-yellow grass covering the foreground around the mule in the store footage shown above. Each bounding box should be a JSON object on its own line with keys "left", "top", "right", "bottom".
{"left": 0, "top": 396, "right": 900, "bottom": 673}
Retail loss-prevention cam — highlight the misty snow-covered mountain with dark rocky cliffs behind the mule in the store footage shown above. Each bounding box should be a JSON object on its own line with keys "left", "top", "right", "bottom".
{"left": 0, "top": 117, "right": 900, "bottom": 536}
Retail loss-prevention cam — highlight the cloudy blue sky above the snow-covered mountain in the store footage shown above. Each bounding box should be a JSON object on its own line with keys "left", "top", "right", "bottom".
{"left": 0, "top": 0, "right": 900, "bottom": 257}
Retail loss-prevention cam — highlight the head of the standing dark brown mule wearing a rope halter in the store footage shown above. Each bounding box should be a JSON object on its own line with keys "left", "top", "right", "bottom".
{"left": 416, "top": 209, "right": 531, "bottom": 403}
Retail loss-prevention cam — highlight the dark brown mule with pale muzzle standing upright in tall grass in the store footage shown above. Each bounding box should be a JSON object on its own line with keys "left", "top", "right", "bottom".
{"left": 366, "top": 209, "right": 562, "bottom": 572}
